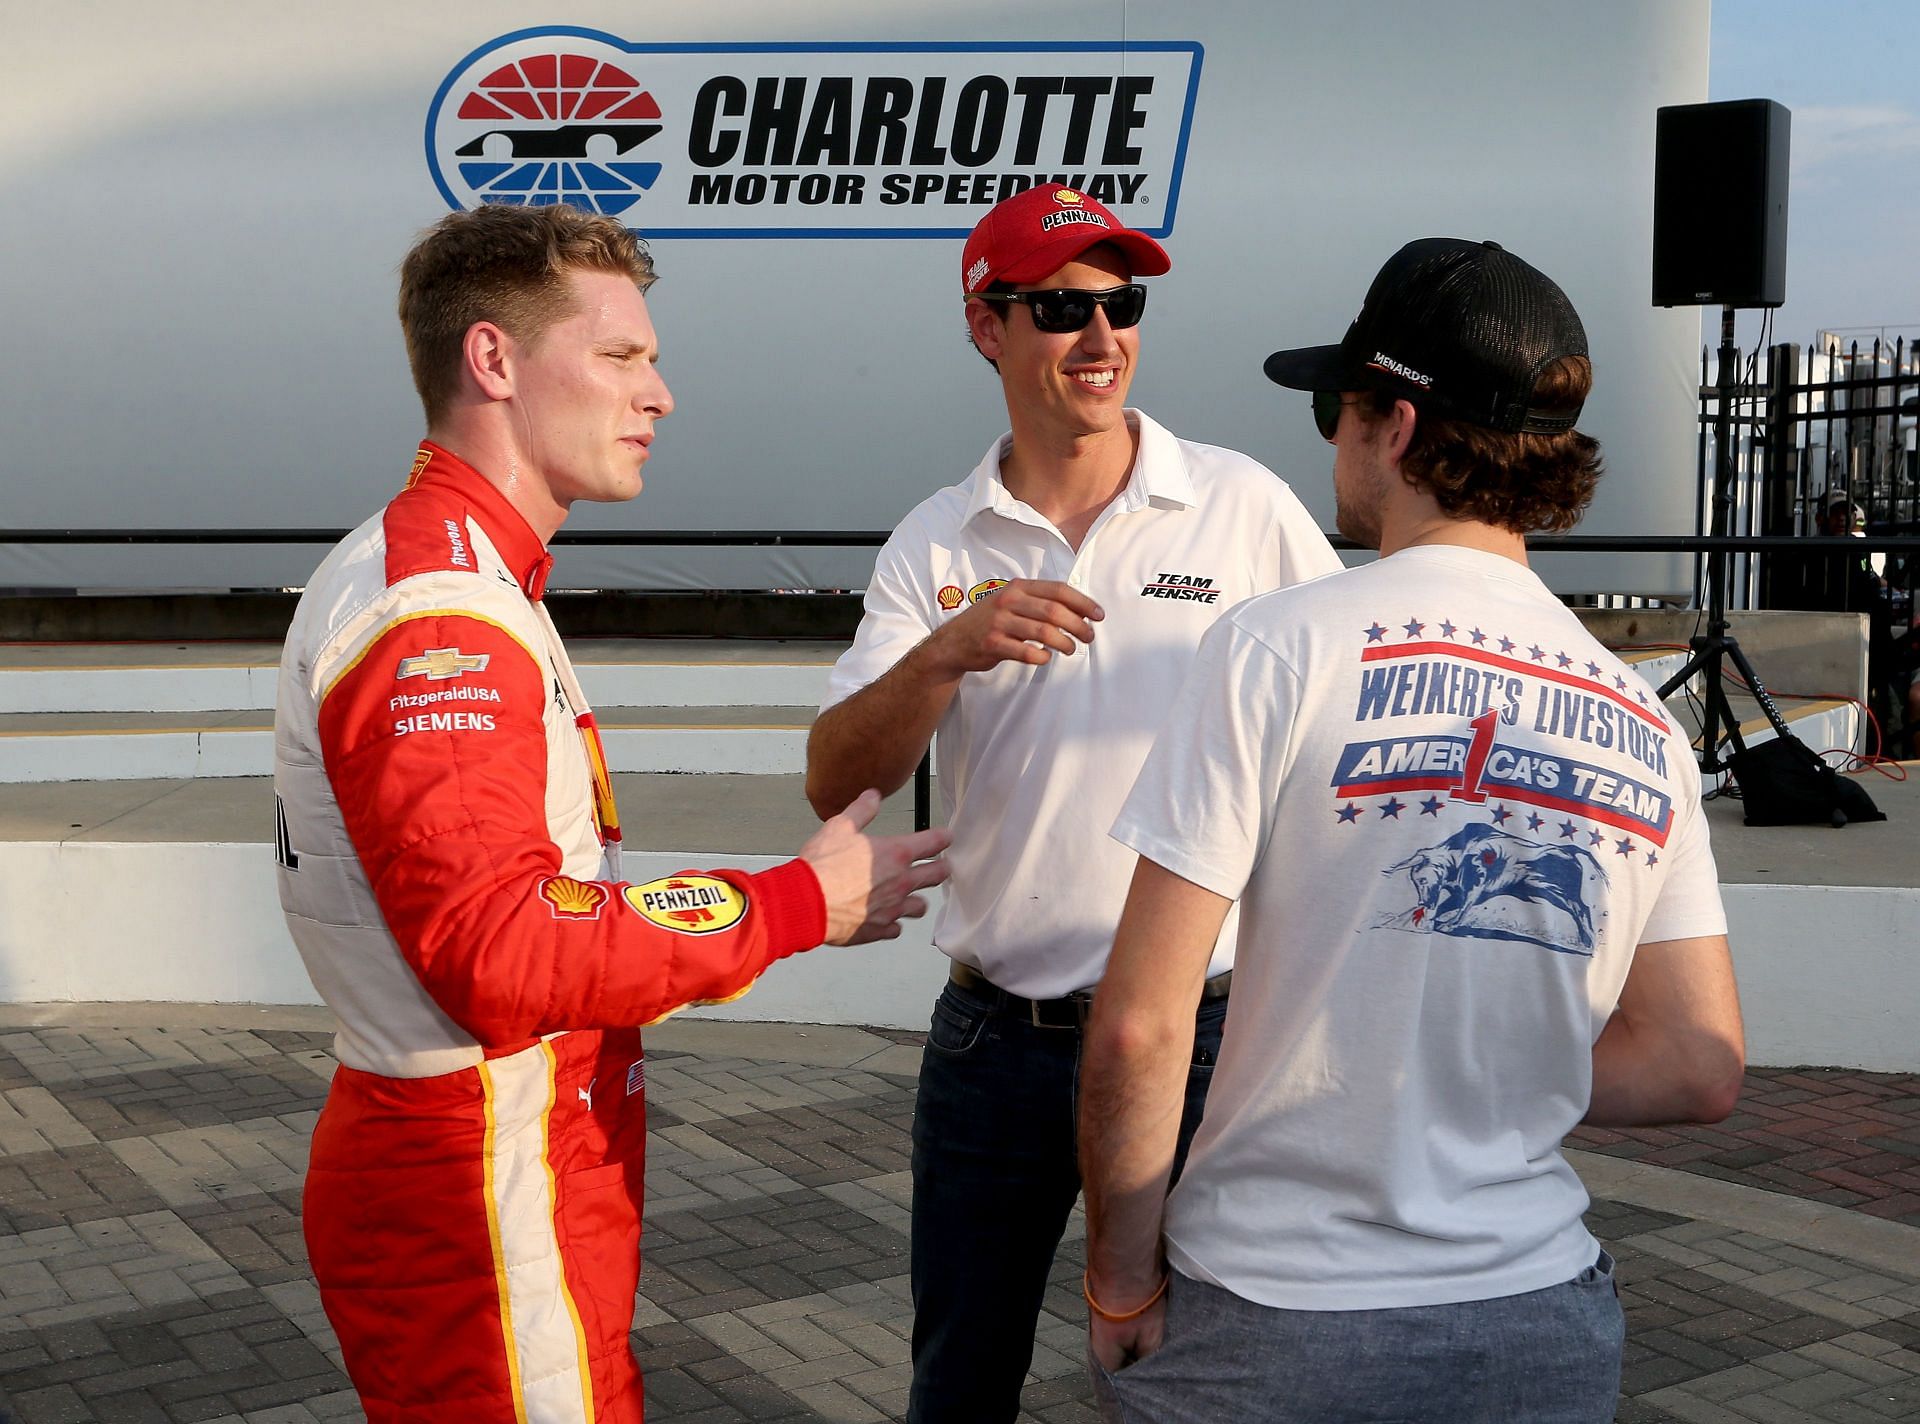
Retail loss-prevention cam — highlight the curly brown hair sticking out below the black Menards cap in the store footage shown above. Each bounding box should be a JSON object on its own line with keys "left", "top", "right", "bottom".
{"left": 1361, "top": 357, "right": 1603, "bottom": 534}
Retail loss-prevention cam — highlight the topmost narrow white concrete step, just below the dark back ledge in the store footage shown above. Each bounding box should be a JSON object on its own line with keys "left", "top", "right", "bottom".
{"left": 0, "top": 639, "right": 845, "bottom": 712}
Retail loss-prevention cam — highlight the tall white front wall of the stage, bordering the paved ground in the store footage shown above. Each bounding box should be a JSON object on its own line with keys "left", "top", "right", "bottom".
{"left": 0, "top": 843, "right": 1920, "bottom": 1073}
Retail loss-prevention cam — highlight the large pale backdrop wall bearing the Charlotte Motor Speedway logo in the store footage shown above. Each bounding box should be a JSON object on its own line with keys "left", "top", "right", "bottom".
{"left": 0, "top": 0, "right": 1709, "bottom": 591}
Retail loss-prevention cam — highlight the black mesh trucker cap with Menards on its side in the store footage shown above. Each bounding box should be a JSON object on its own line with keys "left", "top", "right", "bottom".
{"left": 1265, "top": 238, "right": 1586, "bottom": 436}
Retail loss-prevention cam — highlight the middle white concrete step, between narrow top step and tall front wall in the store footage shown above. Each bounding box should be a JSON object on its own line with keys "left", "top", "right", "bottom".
{"left": 0, "top": 704, "right": 814, "bottom": 783}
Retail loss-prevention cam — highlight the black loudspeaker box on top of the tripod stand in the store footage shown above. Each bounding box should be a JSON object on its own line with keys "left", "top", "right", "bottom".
{"left": 1653, "top": 100, "right": 1788, "bottom": 307}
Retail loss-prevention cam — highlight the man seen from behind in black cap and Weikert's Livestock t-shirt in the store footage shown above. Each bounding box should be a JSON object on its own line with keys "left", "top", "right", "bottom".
{"left": 1081, "top": 238, "right": 1743, "bottom": 1424}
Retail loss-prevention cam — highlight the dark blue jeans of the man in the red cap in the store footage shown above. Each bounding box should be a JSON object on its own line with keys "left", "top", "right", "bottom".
{"left": 906, "top": 985, "right": 1227, "bottom": 1424}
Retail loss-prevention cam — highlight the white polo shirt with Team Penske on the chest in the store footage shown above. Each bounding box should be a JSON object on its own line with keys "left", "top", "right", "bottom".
{"left": 824, "top": 409, "right": 1340, "bottom": 998}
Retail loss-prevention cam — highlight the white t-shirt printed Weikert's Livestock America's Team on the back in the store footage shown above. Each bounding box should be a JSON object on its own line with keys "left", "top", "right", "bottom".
{"left": 1114, "top": 545, "right": 1726, "bottom": 1311}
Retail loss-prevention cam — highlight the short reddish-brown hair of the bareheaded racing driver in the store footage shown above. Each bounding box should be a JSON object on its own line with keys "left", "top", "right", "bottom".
{"left": 399, "top": 203, "right": 655, "bottom": 426}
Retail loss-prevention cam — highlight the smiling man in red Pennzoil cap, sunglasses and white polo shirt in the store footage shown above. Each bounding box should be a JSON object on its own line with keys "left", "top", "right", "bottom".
{"left": 806, "top": 184, "right": 1340, "bottom": 1424}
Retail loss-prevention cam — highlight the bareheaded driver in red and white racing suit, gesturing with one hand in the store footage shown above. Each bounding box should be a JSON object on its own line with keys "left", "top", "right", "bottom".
{"left": 275, "top": 207, "right": 947, "bottom": 1424}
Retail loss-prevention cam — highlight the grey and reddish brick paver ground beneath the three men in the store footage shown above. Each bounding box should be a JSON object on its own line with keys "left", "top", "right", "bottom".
{"left": 0, "top": 1009, "right": 1920, "bottom": 1424}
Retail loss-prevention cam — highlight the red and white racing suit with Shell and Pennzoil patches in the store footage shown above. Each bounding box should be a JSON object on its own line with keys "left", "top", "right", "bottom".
{"left": 275, "top": 443, "right": 826, "bottom": 1424}
